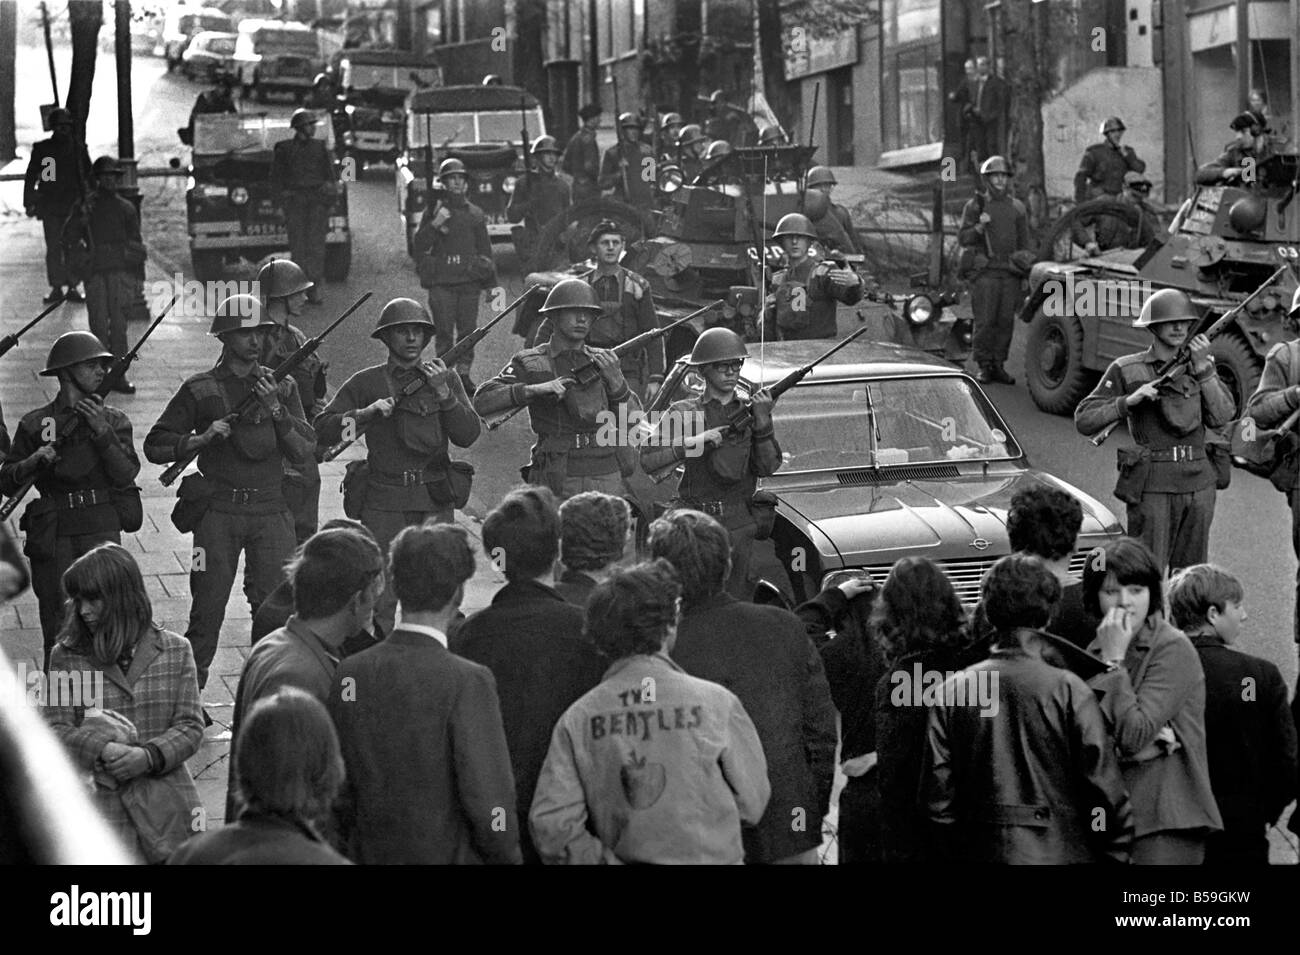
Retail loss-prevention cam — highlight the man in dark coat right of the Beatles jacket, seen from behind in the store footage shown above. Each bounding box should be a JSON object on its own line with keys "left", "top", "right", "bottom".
{"left": 649, "top": 511, "right": 837, "bottom": 865}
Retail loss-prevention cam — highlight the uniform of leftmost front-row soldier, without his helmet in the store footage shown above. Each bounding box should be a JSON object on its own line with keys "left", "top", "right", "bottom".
{"left": 0, "top": 398, "right": 140, "bottom": 657}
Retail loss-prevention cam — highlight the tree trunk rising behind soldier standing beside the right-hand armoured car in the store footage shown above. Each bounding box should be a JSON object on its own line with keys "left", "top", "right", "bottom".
{"left": 998, "top": 0, "right": 1052, "bottom": 229}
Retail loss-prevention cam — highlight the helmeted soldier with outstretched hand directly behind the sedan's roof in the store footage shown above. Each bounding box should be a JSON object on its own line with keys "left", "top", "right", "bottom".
{"left": 763, "top": 212, "right": 862, "bottom": 340}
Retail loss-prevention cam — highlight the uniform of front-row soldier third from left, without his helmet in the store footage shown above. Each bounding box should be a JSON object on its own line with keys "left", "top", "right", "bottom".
{"left": 315, "top": 359, "right": 481, "bottom": 631}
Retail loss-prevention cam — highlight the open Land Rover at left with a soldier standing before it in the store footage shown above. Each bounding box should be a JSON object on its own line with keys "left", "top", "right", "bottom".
{"left": 185, "top": 113, "right": 352, "bottom": 282}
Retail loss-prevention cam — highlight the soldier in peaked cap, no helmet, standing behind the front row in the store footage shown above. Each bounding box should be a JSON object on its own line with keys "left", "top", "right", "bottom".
{"left": 537, "top": 218, "right": 664, "bottom": 403}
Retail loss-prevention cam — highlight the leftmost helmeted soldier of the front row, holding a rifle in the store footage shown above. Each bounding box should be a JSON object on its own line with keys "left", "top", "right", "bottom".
{"left": 0, "top": 331, "right": 143, "bottom": 664}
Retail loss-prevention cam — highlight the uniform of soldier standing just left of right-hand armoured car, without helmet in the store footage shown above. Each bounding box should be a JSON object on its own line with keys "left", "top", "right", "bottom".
{"left": 957, "top": 190, "right": 1030, "bottom": 368}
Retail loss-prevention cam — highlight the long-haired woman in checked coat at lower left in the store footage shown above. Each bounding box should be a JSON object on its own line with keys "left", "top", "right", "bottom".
{"left": 48, "top": 543, "right": 203, "bottom": 861}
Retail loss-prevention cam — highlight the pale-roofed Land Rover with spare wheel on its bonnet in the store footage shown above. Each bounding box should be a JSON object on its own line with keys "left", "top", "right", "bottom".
{"left": 397, "top": 86, "right": 546, "bottom": 252}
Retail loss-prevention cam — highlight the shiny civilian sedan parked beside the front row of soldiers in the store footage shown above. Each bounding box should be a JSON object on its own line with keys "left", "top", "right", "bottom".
{"left": 632, "top": 339, "right": 1123, "bottom": 604}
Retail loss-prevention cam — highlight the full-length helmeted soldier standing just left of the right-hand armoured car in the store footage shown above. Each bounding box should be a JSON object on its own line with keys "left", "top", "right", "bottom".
{"left": 957, "top": 156, "right": 1032, "bottom": 385}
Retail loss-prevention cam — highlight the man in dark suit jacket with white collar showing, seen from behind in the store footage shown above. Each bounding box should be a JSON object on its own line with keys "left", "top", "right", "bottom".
{"left": 329, "top": 524, "right": 521, "bottom": 865}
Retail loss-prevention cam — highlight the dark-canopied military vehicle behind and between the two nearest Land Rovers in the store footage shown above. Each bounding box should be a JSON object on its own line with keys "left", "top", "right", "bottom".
{"left": 332, "top": 49, "right": 442, "bottom": 173}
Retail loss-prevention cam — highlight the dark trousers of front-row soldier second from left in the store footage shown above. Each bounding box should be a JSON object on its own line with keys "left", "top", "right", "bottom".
{"left": 185, "top": 508, "right": 295, "bottom": 690}
